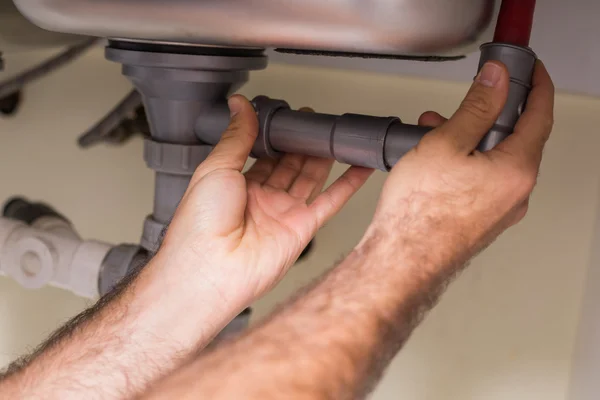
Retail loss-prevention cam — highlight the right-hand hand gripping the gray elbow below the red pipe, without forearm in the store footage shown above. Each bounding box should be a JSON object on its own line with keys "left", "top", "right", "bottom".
{"left": 365, "top": 62, "right": 554, "bottom": 272}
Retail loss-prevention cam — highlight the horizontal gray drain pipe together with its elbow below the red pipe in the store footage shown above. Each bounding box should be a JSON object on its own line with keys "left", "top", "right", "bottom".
{"left": 195, "top": 43, "right": 537, "bottom": 171}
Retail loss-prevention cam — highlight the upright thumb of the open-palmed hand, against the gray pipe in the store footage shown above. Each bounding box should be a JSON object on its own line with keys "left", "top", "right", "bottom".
{"left": 192, "top": 95, "right": 258, "bottom": 182}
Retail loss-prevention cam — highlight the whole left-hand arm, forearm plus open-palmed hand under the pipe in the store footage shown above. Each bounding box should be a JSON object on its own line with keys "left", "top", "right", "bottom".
{"left": 0, "top": 96, "right": 372, "bottom": 400}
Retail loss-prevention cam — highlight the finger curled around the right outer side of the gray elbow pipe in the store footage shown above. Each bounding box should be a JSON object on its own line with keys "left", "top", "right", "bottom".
{"left": 498, "top": 61, "right": 555, "bottom": 164}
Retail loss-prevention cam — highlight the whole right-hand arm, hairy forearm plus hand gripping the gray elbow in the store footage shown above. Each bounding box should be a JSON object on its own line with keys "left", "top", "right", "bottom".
{"left": 141, "top": 62, "right": 554, "bottom": 399}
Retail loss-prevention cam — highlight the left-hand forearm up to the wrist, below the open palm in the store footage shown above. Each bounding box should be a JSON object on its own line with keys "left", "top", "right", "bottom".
{"left": 0, "top": 250, "right": 243, "bottom": 399}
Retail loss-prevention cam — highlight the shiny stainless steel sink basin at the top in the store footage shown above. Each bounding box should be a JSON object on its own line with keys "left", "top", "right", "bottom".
{"left": 14, "top": 0, "right": 494, "bottom": 55}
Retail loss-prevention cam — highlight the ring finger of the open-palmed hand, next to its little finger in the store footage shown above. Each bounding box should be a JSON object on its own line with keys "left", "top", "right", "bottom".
{"left": 288, "top": 157, "right": 335, "bottom": 202}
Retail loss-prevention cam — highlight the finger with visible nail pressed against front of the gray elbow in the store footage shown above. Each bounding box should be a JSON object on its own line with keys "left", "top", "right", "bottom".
{"left": 428, "top": 61, "right": 509, "bottom": 154}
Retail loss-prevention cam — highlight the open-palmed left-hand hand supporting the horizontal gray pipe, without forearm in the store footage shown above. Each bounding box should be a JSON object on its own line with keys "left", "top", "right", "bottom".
{"left": 159, "top": 96, "right": 372, "bottom": 301}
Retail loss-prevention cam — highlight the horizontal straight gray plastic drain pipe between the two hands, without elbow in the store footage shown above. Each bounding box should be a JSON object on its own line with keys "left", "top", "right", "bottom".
{"left": 196, "top": 96, "right": 431, "bottom": 171}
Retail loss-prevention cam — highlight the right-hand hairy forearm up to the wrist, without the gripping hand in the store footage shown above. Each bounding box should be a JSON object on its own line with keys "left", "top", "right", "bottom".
{"left": 143, "top": 223, "right": 460, "bottom": 399}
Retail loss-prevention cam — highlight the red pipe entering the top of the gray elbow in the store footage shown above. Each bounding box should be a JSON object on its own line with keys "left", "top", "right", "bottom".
{"left": 494, "top": 0, "right": 536, "bottom": 47}
